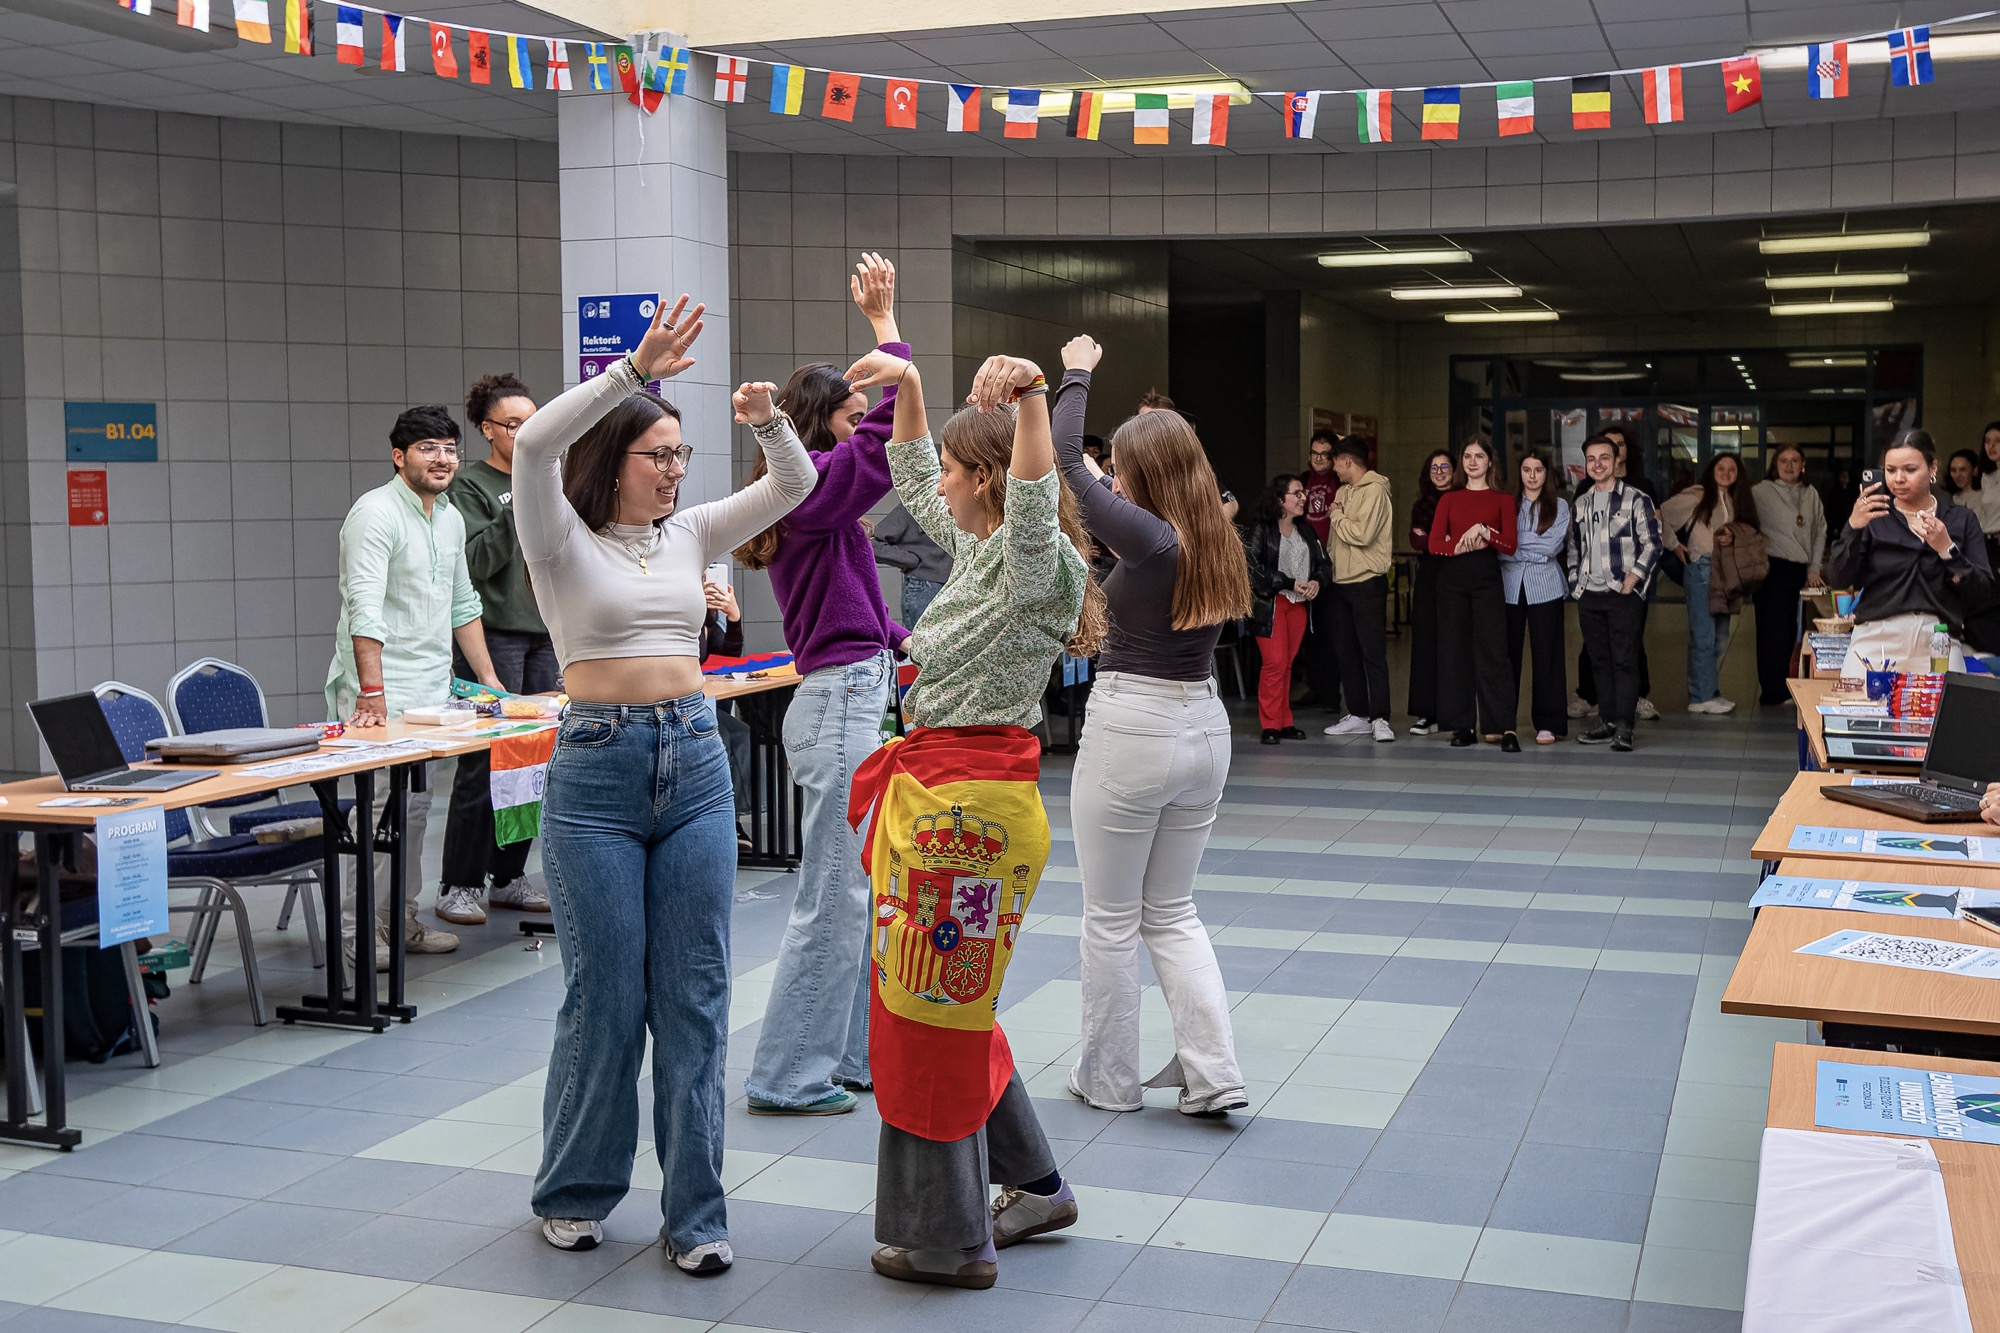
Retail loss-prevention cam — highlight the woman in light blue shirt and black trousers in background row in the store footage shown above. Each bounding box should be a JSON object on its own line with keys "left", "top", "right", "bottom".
{"left": 1500, "top": 454, "right": 1570, "bottom": 745}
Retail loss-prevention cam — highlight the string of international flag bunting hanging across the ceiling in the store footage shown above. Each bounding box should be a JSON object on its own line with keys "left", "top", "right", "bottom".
{"left": 116, "top": 0, "right": 2000, "bottom": 146}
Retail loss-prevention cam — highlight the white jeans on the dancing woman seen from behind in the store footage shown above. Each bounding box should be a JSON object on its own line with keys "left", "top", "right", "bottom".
{"left": 1070, "top": 671, "right": 1244, "bottom": 1111}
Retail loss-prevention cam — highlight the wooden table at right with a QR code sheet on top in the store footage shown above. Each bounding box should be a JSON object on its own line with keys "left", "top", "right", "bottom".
{"left": 1722, "top": 857, "right": 2000, "bottom": 1059}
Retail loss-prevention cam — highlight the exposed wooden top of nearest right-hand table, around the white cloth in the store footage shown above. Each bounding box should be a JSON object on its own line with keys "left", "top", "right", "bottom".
{"left": 1764, "top": 1040, "right": 2000, "bottom": 1333}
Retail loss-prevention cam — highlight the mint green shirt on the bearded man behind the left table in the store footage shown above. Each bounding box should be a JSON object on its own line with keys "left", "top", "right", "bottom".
{"left": 326, "top": 476, "right": 480, "bottom": 719}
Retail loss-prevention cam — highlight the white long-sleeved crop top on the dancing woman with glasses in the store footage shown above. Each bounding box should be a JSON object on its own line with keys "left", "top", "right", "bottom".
{"left": 514, "top": 360, "right": 818, "bottom": 667}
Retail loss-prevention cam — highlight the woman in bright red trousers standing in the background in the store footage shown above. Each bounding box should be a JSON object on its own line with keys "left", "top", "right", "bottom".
{"left": 1244, "top": 472, "right": 1332, "bottom": 745}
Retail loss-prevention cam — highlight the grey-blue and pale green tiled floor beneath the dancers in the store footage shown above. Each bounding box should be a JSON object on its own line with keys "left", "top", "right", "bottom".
{"left": 0, "top": 696, "right": 1806, "bottom": 1333}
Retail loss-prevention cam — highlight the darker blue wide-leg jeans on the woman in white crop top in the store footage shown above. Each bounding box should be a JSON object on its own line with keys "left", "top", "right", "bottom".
{"left": 534, "top": 695, "right": 736, "bottom": 1255}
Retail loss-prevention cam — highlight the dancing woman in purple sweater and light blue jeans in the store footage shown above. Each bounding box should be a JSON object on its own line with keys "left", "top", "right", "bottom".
{"left": 736, "top": 254, "right": 910, "bottom": 1115}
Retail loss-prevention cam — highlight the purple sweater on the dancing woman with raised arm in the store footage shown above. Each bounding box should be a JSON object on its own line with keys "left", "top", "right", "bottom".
{"left": 770, "top": 342, "right": 910, "bottom": 675}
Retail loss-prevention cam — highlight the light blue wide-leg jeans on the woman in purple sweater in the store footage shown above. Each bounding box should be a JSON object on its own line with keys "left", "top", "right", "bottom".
{"left": 744, "top": 652, "right": 894, "bottom": 1107}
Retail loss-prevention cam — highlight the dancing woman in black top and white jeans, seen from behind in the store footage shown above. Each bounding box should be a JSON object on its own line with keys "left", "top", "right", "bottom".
{"left": 1050, "top": 338, "right": 1250, "bottom": 1115}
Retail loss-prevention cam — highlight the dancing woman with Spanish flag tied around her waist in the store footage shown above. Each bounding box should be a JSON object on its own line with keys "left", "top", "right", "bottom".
{"left": 848, "top": 342, "right": 1104, "bottom": 1287}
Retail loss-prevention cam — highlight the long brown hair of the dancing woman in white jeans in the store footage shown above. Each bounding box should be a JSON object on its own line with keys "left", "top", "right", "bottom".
{"left": 1112, "top": 408, "right": 1250, "bottom": 628}
